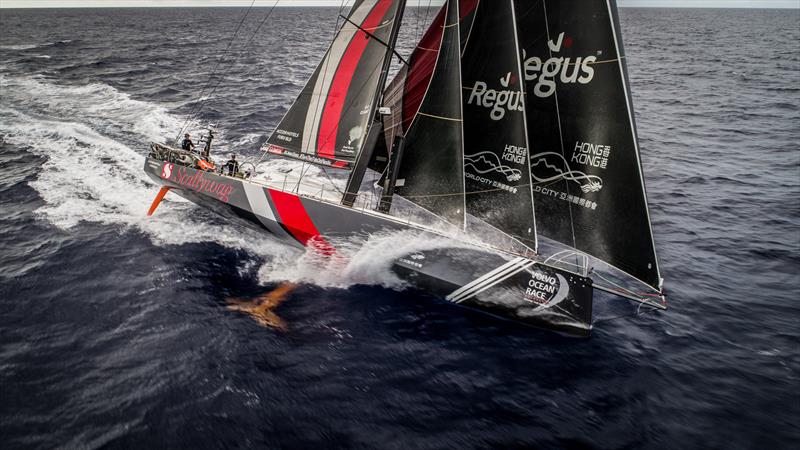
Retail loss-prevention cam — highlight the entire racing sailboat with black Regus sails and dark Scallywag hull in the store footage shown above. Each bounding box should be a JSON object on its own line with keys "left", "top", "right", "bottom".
{"left": 145, "top": 0, "right": 666, "bottom": 336}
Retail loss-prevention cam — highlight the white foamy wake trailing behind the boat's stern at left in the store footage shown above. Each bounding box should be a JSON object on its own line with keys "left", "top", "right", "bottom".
{"left": 0, "top": 76, "right": 272, "bottom": 253}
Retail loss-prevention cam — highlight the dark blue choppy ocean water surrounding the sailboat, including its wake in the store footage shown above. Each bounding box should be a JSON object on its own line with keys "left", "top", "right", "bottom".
{"left": 0, "top": 8, "right": 800, "bottom": 449}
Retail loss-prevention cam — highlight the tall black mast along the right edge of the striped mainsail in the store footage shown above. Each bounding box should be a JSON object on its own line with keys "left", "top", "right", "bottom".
{"left": 342, "top": 0, "right": 406, "bottom": 206}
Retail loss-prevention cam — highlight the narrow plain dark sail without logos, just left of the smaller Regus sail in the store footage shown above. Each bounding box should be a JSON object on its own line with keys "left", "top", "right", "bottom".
{"left": 396, "top": 0, "right": 466, "bottom": 226}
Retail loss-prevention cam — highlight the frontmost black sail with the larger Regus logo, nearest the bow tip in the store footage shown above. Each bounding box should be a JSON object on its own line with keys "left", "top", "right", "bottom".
{"left": 516, "top": 0, "right": 660, "bottom": 289}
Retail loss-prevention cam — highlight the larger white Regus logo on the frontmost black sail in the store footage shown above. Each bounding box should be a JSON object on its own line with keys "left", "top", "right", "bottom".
{"left": 522, "top": 32, "right": 601, "bottom": 98}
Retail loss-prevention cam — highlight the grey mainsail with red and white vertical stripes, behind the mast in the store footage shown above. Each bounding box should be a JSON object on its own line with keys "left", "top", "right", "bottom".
{"left": 265, "top": 0, "right": 405, "bottom": 168}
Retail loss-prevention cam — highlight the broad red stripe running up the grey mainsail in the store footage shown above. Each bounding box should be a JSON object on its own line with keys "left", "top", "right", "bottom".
{"left": 317, "top": 0, "right": 393, "bottom": 159}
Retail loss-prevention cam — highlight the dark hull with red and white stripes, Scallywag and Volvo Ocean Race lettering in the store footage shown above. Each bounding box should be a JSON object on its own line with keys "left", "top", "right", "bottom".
{"left": 145, "top": 158, "right": 592, "bottom": 336}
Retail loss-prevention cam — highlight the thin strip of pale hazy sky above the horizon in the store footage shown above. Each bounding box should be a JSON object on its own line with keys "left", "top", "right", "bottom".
{"left": 0, "top": 0, "right": 800, "bottom": 8}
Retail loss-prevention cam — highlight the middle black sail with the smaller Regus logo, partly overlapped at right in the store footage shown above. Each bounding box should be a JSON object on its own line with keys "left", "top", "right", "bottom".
{"left": 461, "top": 0, "right": 536, "bottom": 249}
